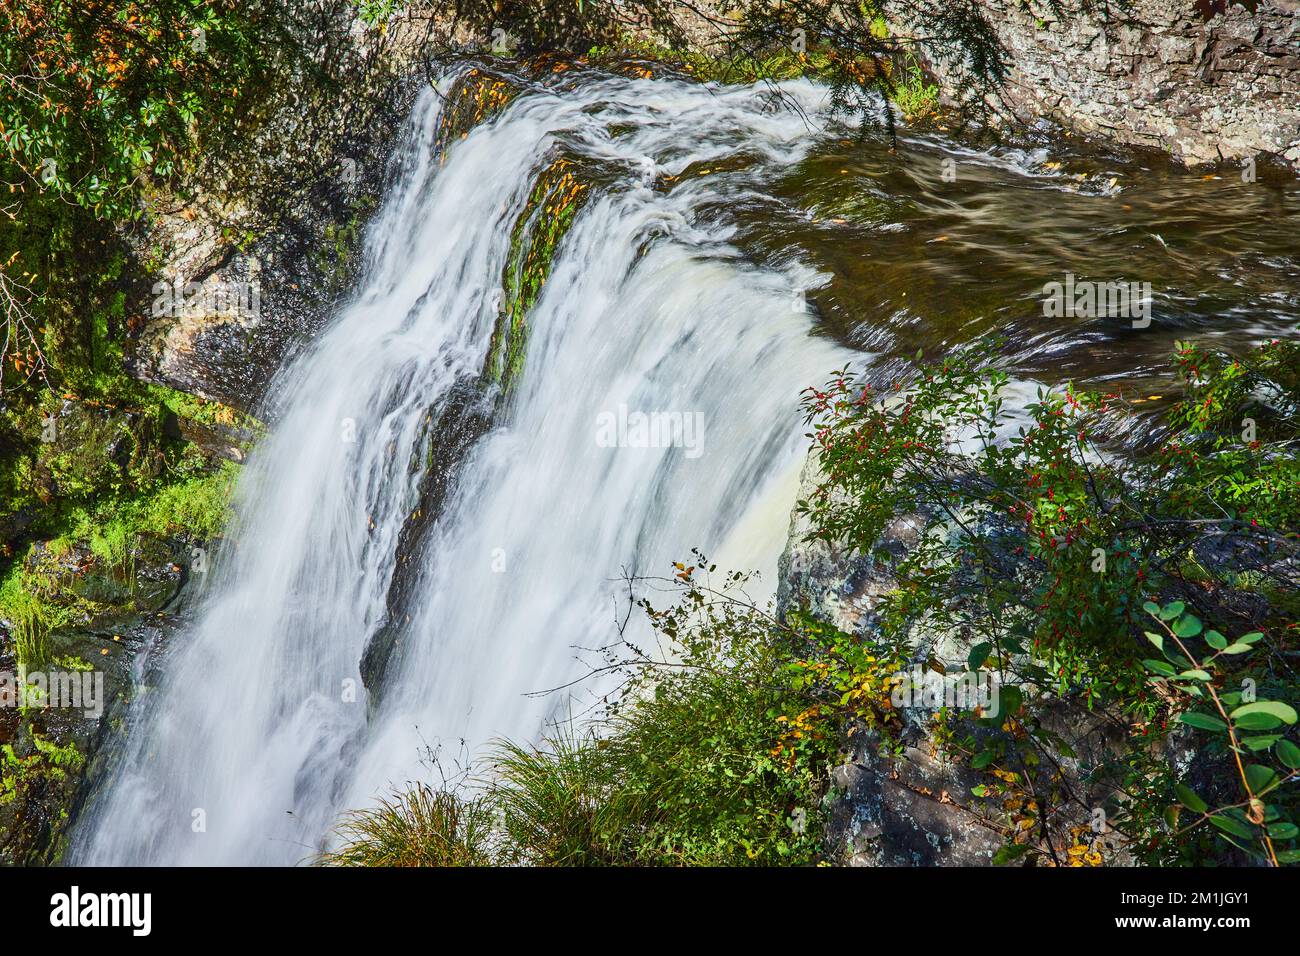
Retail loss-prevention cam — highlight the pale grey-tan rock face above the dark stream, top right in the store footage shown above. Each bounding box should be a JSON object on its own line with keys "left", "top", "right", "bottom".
{"left": 902, "top": 0, "right": 1300, "bottom": 172}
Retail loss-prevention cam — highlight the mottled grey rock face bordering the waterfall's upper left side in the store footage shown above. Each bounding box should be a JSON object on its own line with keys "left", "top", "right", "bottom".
{"left": 127, "top": 25, "right": 423, "bottom": 412}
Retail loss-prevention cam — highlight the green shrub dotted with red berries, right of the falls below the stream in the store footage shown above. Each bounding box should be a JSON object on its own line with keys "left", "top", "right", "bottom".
{"left": 798, "top": 343, "right": 1300, "bottom": 862}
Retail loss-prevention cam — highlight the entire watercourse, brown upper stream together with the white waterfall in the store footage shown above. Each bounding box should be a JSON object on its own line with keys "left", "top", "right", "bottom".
{"left": 72, "top": 61, "right": 1300, "bottom": 864}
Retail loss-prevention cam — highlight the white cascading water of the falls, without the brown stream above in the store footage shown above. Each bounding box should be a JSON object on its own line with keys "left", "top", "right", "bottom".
{"left": 73, "top": 69, "right": 846, "bottom": 864}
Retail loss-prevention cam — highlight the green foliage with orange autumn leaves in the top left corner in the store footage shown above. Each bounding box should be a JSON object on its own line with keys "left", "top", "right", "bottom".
{"left": 0, "top": 0, "right": 281, "bottom": 217}
